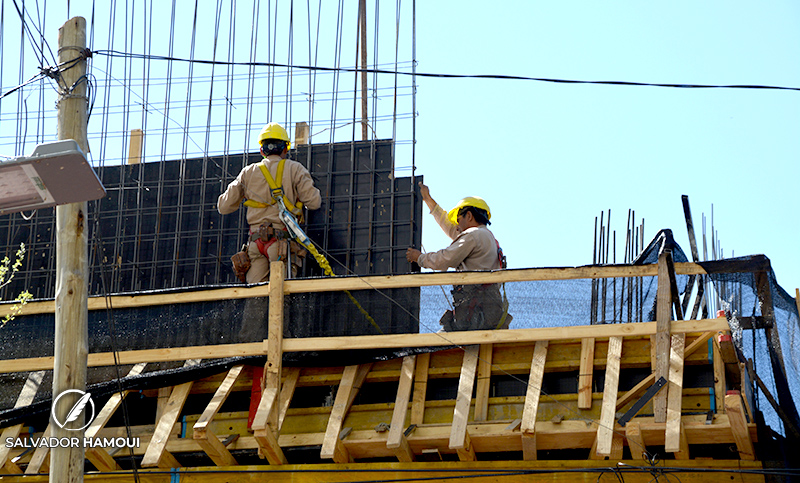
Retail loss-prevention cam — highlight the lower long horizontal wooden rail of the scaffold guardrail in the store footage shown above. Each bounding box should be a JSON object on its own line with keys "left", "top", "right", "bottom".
{"left": 0, "top": 318, "right": 730, "bottom": 373}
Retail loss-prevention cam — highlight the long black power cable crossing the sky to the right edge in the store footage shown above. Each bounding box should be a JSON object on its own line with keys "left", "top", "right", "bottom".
{"left": 94, "top": 50, "right": 800, "bottom": 91}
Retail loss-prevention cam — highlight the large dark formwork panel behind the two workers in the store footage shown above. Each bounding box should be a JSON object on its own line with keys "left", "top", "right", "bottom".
{"left": 0, "top": 140, "right": 422, "bottom": 300}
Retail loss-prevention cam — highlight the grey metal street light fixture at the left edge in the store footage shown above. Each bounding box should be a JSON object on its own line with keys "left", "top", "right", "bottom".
{"left": 0, "top": 139, "right": 106, "bottom": 215}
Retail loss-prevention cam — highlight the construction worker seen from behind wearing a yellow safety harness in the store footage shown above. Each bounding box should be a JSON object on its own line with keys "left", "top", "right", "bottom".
{"left": 217, "top": 122, "right": 321, "bottom": 283}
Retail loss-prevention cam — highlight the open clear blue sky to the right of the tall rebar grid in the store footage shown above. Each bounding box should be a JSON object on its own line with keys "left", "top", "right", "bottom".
{"left": 417, "top": 1, "right": 800, "bottom": 295}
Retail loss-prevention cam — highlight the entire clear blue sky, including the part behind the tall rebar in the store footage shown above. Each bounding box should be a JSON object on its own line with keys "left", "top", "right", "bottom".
{"left": 0, "top": 0, "right": 800, "bottom": 295}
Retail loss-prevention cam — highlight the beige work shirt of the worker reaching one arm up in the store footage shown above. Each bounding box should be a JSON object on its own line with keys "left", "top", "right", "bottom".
{"left": 417, "top": 205, "right": 503, "bottom": 270}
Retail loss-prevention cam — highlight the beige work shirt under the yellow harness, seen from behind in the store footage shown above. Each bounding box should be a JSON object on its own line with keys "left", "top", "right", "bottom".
{"left": 217, "top": 154, "right": 322, "bottom": 232}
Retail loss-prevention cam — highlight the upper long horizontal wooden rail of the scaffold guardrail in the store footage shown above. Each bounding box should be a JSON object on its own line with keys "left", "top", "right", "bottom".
{"left": 0, "top": 262, "right": 712, "bottom": 316}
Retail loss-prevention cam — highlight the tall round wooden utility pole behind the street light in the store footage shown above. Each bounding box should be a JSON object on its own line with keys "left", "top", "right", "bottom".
{"left": 50, "top": 17, "right": 89, "bottom": 483}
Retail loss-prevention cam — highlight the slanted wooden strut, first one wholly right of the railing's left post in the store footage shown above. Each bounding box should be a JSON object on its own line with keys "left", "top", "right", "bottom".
{"left": 320, "top": 363, "right": 372, "bottom": 463}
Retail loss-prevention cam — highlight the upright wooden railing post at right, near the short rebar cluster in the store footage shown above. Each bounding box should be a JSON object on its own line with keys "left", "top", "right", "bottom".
{"left": 653, "top": 250, "right": 672, "bottom": 423}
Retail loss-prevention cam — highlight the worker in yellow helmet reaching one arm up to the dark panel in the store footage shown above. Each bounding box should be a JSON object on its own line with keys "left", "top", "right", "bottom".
{"left": 406, "top": 183, "right": 512, "bottom": 332}
